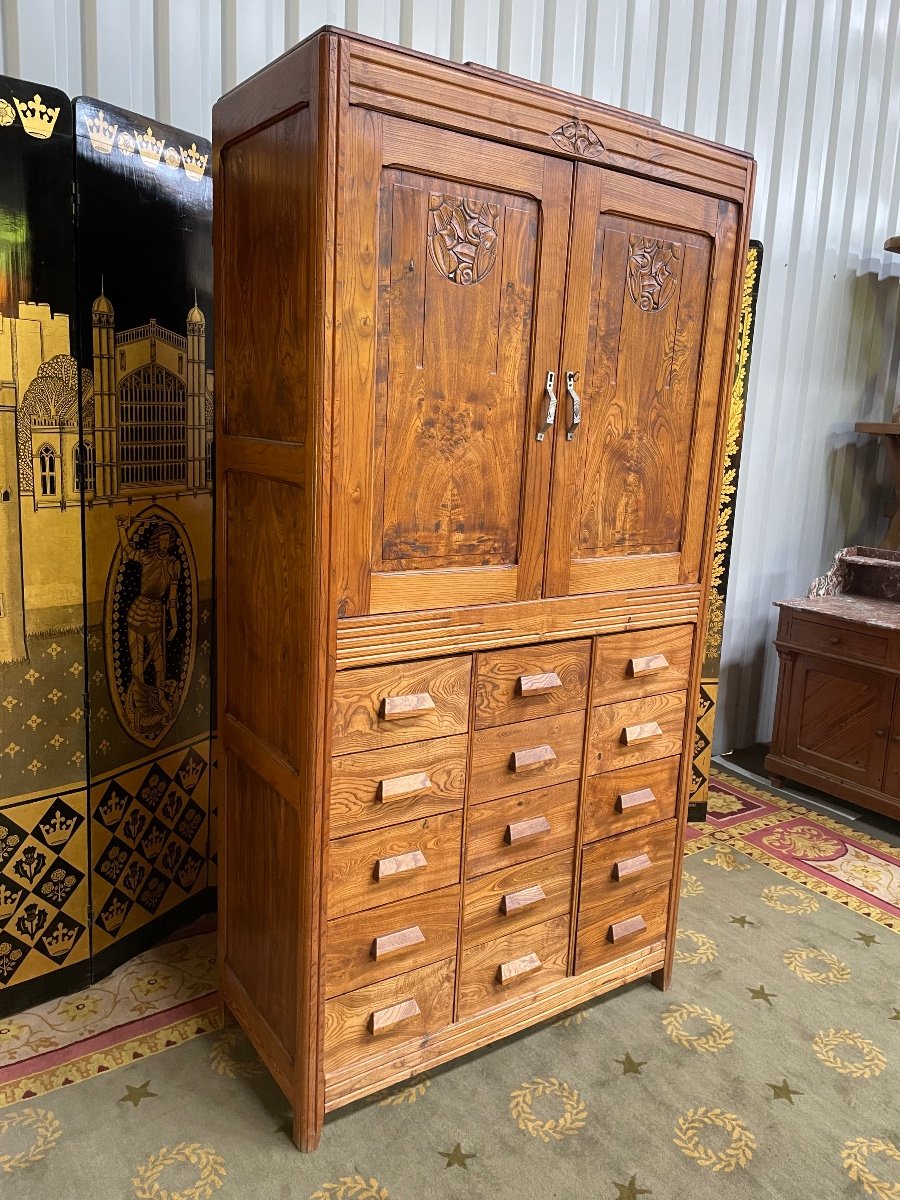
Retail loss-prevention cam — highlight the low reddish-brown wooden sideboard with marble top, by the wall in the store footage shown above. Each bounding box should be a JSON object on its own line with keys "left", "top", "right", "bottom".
{"left": 766, "top": 595, "right": 900, "bottom": 817}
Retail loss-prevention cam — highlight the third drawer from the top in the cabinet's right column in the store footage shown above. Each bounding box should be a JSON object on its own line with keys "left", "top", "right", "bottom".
{"left": 582, "top": 758, "right": 682, "bottom": 842}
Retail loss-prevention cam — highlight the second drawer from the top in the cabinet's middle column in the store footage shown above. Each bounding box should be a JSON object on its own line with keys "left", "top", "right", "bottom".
{"left": 469, "top": 713, "right": 584, "bottom": 804}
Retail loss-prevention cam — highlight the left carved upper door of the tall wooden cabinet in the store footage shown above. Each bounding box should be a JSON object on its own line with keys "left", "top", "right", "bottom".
{"left": 332, "top": 108, "right": 572, "bottom": 616}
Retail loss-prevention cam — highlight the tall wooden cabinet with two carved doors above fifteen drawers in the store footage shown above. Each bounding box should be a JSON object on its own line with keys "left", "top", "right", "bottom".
{"left": 215, "top": 29, "right": 754, "bottom": 1147}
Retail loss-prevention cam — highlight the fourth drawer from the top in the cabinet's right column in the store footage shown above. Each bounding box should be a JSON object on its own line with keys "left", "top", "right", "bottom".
{"left": 578, "top": 821, "right": 676, "bottom": 912}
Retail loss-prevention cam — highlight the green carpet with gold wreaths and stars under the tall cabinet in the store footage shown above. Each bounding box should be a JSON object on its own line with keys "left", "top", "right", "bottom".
{"left": 0, "top": 763, "right": 900, "bottom": 1200}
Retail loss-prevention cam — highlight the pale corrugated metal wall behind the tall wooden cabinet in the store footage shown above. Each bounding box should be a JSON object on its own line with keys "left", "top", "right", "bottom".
{"left": 0, "top": 0, "right": 900, "bottom": 748}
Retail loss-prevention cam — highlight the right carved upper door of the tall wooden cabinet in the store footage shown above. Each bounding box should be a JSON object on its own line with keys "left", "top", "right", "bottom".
{"left": 546, "top": 163, "right": 738, "bottom": 595}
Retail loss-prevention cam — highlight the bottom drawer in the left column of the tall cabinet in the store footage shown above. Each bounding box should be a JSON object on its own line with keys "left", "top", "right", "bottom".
{"left": 324, "top": 959, "right": 456, "bottom": 1073}
